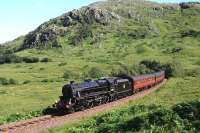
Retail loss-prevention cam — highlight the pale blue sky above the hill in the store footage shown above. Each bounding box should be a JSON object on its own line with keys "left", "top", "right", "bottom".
{"left": 0, "top": 0, "right": 200, "bottom": 44}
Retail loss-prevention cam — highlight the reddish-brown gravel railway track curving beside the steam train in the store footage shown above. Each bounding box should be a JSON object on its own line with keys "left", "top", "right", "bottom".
{"left": 0, "top": 80, "right": 166, "bottom": 133}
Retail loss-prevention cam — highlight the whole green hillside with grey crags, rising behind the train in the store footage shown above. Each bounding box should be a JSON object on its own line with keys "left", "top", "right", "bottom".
{"left": 0, "top": 0, "right": 200, "bottom": 130}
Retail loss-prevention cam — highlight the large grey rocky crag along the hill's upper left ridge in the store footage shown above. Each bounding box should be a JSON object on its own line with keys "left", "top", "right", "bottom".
{"left": 21, "top": 7, "right": 118, "bottom": 49}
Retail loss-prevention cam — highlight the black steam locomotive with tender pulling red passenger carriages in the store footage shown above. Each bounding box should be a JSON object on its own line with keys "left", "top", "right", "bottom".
{"left": 54, "top": 71, "right": 165, "bottom": 112}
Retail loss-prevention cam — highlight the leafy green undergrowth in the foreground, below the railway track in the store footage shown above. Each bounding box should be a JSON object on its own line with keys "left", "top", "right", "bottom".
{"left": 48, "top": 97, "right": 200, "bottom": 133}
